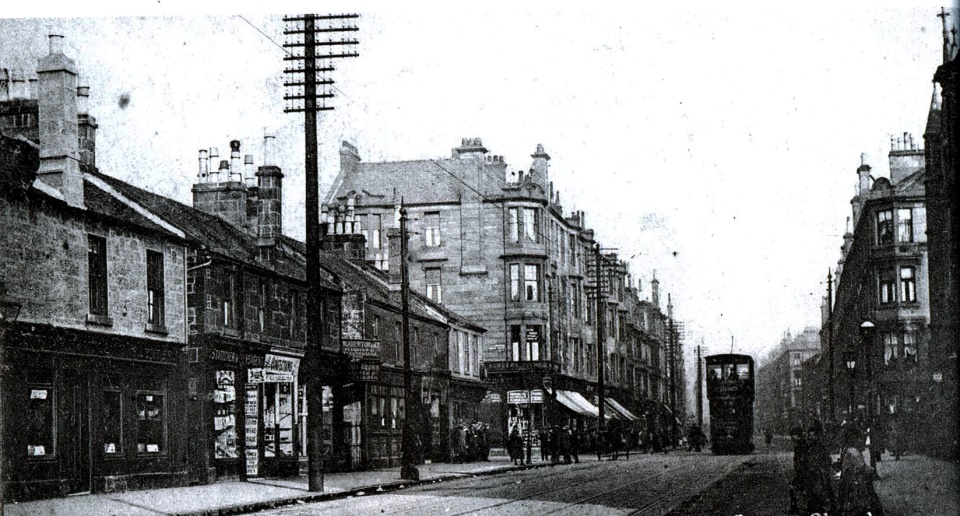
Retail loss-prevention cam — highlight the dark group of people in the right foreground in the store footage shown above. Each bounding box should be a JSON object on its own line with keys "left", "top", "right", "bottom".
{"left": 789, "top": 422, "right": 883, "bottom": 516}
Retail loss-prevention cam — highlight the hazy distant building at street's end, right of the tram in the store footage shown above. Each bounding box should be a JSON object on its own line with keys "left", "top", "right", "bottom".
{"left": 754, "top": 327, "right": 820, "bottom": 434}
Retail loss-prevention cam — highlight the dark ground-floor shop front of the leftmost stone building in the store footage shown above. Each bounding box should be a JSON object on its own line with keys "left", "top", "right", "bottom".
{"left": 0, "top": 325, "right": 187, "bottom": 501}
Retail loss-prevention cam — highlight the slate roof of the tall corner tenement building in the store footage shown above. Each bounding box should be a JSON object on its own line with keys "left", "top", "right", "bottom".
{"left": 324, "top": 159, "right": 505, "bottom": 204}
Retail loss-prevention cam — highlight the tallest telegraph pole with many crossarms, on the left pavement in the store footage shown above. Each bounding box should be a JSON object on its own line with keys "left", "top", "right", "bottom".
{"left": 283, "top": 10, "right": 360, "bottom": 491}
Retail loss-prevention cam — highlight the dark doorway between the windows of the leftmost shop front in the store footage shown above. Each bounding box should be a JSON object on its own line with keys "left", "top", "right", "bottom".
{"left": 60, "top": 370, "right": 93, "bottom": 494}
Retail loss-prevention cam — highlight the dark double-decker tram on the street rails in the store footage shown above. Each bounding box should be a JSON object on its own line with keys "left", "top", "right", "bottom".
{"left": 706, "top": 353, "right": 754, "bottom": 455}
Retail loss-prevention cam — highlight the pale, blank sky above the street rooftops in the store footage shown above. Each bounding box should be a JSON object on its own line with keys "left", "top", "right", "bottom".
{"left": 0, "top": 0, "right": 958, "bottom": 366}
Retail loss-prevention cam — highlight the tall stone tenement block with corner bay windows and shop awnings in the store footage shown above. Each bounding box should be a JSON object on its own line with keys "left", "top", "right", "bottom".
{"left": 323, "top": 138, "right": 683, "bottom": 446}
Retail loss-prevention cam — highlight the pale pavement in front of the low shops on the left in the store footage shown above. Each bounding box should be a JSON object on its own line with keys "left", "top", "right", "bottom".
{"left": 3, "top": 452, "right": 550, "bottom": 516}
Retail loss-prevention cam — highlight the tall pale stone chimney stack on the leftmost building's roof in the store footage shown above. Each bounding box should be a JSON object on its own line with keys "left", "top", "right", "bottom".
{"left": 37, "top": 34, "right": 84, "bottom": 208}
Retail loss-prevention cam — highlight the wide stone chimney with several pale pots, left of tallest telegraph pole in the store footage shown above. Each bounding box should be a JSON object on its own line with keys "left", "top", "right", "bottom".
{"left": 191, "top": 140, "right": 249, "bottom": 230}
